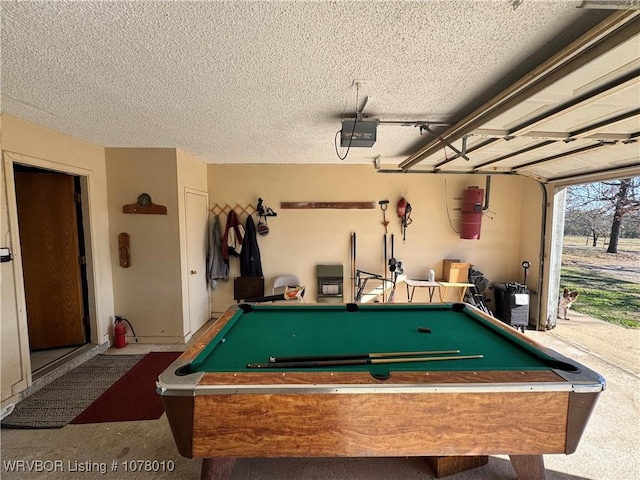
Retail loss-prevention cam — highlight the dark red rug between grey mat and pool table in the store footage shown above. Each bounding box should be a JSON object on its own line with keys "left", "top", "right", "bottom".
{"left": 71, "top": 352, "right": 182, "bottom": 424}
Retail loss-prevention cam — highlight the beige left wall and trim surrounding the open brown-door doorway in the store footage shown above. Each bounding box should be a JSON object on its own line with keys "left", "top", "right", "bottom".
{"left": 0, "top": 114, "right": 113, "bottom": 401}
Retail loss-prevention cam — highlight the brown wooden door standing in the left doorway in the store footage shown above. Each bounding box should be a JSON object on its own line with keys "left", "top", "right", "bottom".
{"left": 15, "top": 172, "right": 86, "bottom": 350}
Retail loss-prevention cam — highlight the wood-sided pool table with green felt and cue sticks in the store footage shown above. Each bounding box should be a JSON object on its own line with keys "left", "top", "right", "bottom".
{"left": 157, "top": 303, "right": 605, "bottom": 480}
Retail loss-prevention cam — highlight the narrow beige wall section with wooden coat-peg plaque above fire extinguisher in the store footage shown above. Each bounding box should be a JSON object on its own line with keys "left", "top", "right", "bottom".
{"left": 105, "top": 148, "right": 183, "bottom": 342}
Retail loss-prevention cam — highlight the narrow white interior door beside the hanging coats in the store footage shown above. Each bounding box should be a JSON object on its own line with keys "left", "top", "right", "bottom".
{"left": 185, "top": 191, "right": 211, "bottom": 334}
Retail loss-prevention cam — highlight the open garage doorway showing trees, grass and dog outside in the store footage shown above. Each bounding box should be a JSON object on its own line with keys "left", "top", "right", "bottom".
{"left": 547, "top": 177, "right": 640, "bottom": 329}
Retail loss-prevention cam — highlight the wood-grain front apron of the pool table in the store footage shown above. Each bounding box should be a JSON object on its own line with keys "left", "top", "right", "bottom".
{"left": 161, "top": 371, "right": 599, "bottom": 458}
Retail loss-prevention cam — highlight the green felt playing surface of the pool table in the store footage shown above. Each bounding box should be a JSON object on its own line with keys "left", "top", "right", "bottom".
{"left": 191, "top": 304, "right": 550, "bottom": 373}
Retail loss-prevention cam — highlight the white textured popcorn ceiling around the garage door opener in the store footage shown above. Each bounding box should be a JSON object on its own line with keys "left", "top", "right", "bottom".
{"left": 0, "top": 0, "right": 637, "bottom": 184}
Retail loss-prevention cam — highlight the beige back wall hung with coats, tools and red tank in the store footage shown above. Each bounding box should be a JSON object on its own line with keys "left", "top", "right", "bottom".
{"left": 208, "top": 165, "right": 542, "bottom": 312}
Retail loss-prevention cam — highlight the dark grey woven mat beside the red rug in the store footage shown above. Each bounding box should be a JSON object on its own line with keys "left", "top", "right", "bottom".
{"left": 2, "top": 355, "right": 144, "bottom": 428}
